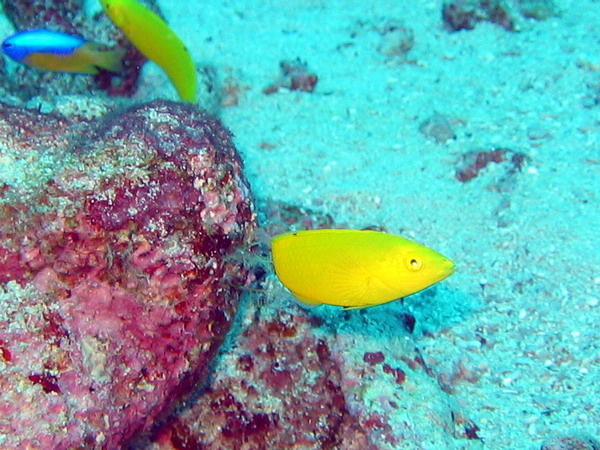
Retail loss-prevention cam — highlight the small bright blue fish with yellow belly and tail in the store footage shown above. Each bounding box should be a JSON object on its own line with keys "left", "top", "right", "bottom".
{"left": 2, "top": 29, "right": 125, "bottom": 74}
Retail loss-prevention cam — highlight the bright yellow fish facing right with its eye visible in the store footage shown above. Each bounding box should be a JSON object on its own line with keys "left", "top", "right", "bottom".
{"left": 271, "top": 230, "right": 454, "bottom": 309}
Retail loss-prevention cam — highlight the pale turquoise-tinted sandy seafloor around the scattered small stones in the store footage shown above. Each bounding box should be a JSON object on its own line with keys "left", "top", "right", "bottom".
{"left": 1, "top": 0, "right": 600, "bottom": 449}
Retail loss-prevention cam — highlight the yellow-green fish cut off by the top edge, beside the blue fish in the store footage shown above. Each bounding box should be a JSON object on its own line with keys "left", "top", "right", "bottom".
{"left": 100, "top": 0, "right": 197, "bottom": 103}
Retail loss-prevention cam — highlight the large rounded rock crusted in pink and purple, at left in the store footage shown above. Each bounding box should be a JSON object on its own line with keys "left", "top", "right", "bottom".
{"left": 0, "top": 102, "right": 254, "bottom": 449}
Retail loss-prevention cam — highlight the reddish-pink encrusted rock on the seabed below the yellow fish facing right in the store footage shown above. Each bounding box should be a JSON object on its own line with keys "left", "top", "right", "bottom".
{"left": 154, "top": 306, "right": 376, "bottom": 450}
